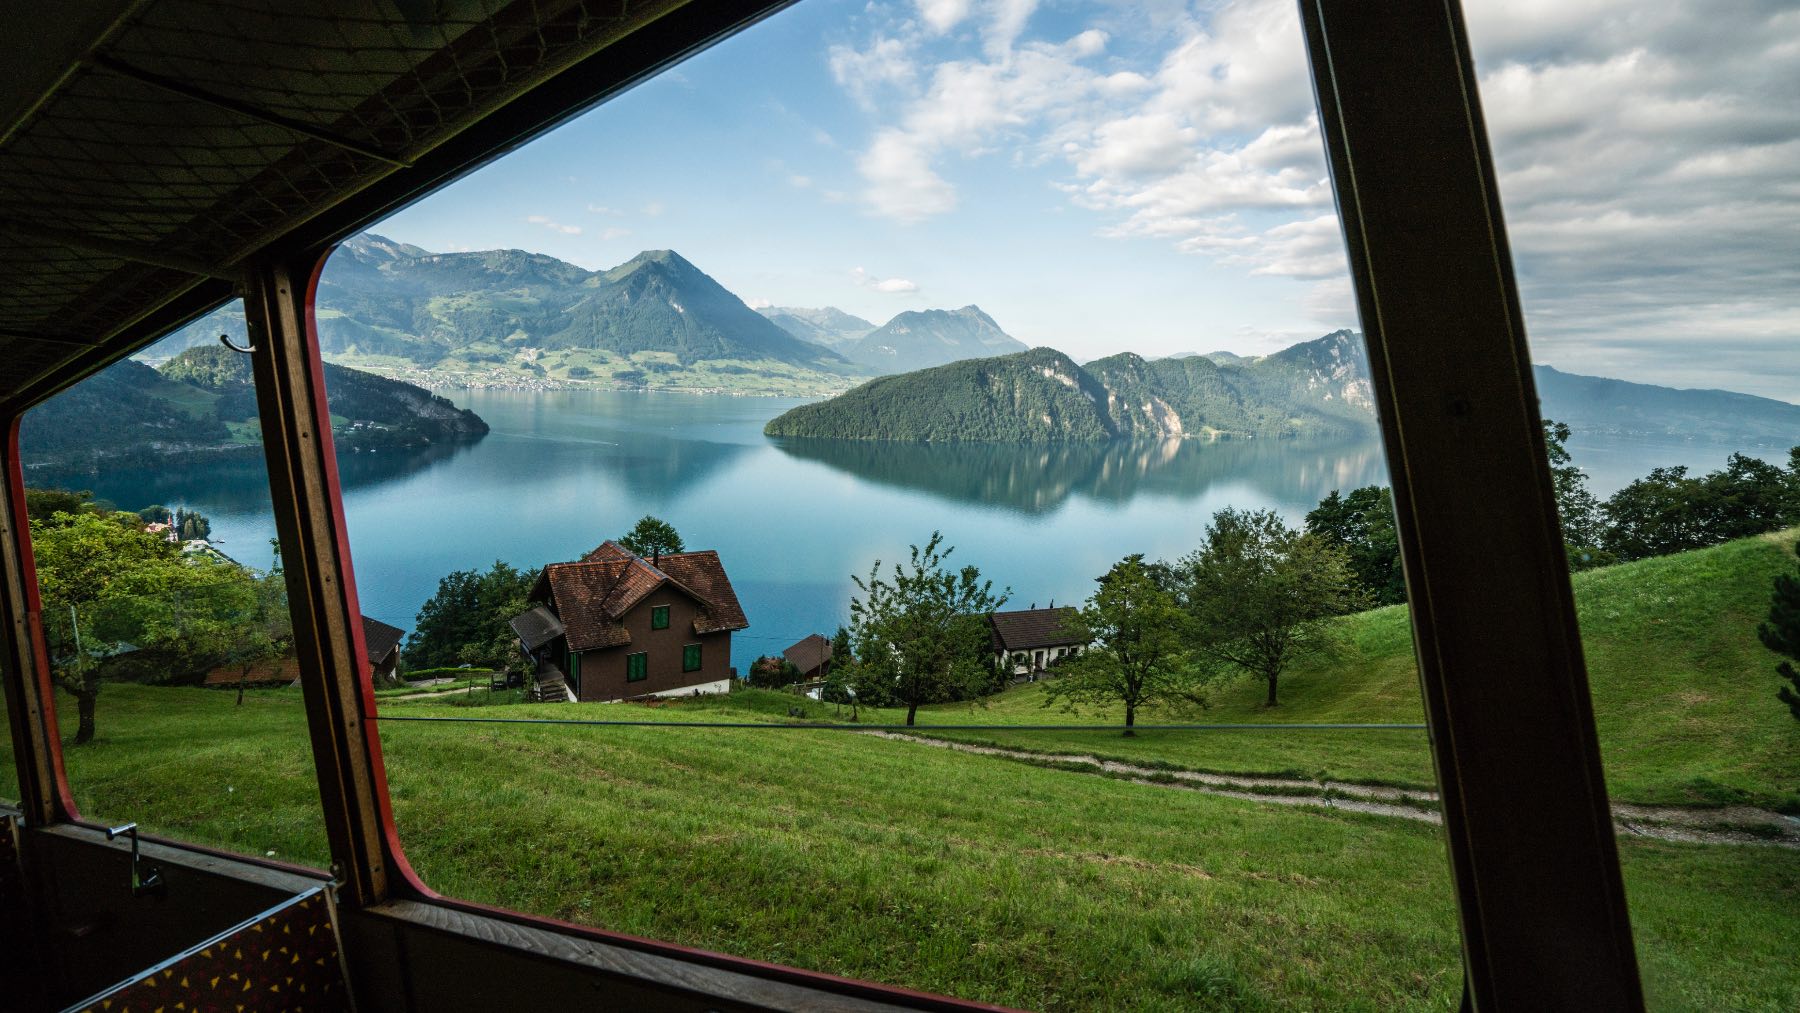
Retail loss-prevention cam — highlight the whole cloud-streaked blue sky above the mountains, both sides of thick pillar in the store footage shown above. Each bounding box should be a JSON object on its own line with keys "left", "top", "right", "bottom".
{"left": 378, "top": 0, "right": 1800, "bottom": 401}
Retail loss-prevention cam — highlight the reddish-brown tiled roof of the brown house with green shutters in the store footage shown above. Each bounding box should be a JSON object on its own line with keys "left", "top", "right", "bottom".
{"left": 544, "top": 542, "right": 751, "bottom": 651}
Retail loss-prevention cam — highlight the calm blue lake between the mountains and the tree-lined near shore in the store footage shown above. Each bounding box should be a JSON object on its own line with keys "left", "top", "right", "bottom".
{"left": 29, "top": 390, "right": 1786, "bottom": 669}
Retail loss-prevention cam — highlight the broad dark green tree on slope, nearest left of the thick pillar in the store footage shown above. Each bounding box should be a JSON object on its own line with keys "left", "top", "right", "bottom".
{"left": 1181, "top": 509, "right": 1364, "bottom": 707}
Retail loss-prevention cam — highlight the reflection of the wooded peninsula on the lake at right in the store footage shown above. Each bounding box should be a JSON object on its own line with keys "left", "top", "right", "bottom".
{"left": 770, "top": 437, "right": 1386, "bottom": 515}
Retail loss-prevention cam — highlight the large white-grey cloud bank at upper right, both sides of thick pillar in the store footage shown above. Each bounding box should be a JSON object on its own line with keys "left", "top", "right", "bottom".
{"left": 833, "top": 0, "right": 1800, "bottom": 399}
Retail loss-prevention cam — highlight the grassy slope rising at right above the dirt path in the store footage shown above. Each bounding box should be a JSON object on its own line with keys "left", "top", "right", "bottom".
{"left": 923, "top": 531, "right": 1800, "bottom": 813}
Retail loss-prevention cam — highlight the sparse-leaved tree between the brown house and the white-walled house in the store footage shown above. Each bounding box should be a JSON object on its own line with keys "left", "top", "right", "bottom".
{"left": 850, "top": 531, "right": 1006, "bottom": 725}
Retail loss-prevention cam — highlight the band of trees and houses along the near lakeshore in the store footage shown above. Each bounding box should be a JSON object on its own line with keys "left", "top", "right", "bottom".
{"left": 27, "top": 425, "right": 1800, "bottom": 741}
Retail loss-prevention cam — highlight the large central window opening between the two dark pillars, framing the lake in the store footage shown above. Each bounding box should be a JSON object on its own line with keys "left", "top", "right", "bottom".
{"left": 319, "top": 2, "right": 1462, "bottom": 1009}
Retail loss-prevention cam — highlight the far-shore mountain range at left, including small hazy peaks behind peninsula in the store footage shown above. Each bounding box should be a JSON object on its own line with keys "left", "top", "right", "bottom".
{"left": 149, "top": 234, "right": 1026, "bottom": 394}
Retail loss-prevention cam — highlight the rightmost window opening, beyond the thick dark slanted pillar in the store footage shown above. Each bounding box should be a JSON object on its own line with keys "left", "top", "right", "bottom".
{"left": 1467, "top": 0, "right": 1800, "bottom": 1009}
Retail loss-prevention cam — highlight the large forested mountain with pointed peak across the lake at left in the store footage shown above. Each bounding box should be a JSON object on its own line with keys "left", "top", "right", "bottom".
{"left": 151, "top": 234, "right": 868, "bottom": 389}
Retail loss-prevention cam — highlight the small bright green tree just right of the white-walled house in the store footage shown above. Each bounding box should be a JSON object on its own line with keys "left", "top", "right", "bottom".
{"left": 1044, "top": 552, "right": 1195, "bottom": 736}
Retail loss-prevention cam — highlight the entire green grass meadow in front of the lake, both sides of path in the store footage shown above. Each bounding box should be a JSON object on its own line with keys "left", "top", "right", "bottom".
{"left": 0, "top": 534, "right": 1800, "bottom": 1009}
